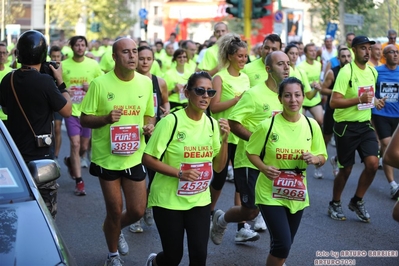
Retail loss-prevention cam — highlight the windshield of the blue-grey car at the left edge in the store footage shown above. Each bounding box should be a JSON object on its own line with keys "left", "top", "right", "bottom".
{"left": 0, "top": 131, "right": 33, "bottom": 203}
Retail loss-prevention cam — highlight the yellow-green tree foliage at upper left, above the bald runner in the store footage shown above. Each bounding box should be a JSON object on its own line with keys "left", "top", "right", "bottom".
{"left": 50, "top": 0, "right": 136, "bottom": 39}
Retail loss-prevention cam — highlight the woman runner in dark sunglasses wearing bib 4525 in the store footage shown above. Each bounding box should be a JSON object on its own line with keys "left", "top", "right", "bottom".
{"left": 143, "top": 72, "right": 230, "bottom": 266}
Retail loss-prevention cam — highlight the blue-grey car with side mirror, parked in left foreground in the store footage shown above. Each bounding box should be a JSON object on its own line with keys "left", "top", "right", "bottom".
{"left": 0, "top": 120, "right": 76, "bottom": 266}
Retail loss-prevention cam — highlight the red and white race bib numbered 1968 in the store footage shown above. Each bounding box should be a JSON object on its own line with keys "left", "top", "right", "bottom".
{"left": 272, "top": 170, "right": 307, "bottom": 201}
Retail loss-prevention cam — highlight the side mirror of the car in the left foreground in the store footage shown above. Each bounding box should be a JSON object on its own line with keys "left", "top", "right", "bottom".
{"left": 28, "top": 159, "right": 61, "bottom": 185}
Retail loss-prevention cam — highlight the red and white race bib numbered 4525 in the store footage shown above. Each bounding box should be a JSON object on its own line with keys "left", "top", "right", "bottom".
{"left": 177, "top": 163, "right": 213, "bottom": 196}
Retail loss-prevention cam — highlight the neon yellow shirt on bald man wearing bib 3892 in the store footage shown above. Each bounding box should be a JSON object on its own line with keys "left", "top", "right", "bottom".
{"left": 80, "top": 71, "right": 155, "bottom": 170}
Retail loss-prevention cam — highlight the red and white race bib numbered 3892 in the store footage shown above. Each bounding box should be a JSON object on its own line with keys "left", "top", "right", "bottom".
{"left": 110, "top": 125, "right": 140, "bottom": 155}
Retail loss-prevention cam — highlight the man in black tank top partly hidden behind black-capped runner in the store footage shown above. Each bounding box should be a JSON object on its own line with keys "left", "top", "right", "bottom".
{"left": 321, "top": 46, "right": 352, "bottom": 176}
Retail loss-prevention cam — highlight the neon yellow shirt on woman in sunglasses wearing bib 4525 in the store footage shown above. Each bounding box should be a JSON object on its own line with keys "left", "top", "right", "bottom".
{"left": 144, "top": 109, "right": 220, "bottom": 210}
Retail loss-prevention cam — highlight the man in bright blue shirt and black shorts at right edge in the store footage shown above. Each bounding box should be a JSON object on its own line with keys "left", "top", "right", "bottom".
{"left": 372, "top": 44, "right": 399, "bottom": 200}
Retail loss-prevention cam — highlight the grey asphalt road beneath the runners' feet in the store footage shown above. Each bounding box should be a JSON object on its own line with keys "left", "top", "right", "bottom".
{"left": 56, "top": 128, "right": 399, "bottom": 266}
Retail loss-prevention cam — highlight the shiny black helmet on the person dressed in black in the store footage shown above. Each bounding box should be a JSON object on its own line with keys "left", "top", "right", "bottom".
{"left": 17, "top": 30, "right": 47, "bottom": 65}
